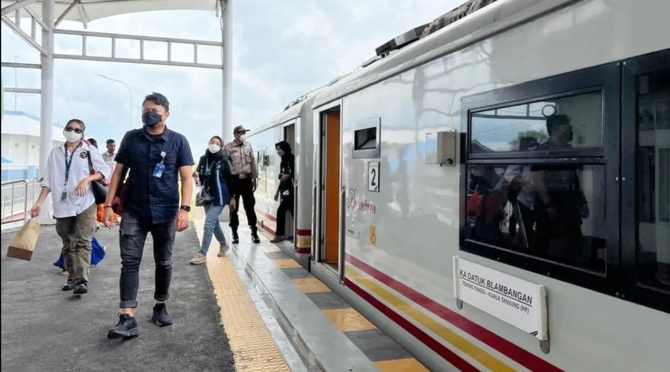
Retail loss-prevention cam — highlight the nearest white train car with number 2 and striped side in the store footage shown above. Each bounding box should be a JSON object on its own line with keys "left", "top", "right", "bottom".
{"left": 308, "top": 0, "right": 670, "bottom": 372}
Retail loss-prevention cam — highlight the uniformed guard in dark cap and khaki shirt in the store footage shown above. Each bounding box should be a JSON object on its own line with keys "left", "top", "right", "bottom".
{"left": 223, "top": 125, "right": 261, "bottom": 244}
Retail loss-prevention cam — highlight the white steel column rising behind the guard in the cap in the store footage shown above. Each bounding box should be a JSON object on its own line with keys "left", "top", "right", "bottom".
{"left": 221, "top": 0, "right": 234, "bottom": 142}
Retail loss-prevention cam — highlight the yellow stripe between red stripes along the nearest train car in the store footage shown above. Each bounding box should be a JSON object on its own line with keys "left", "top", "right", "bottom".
{"left": 347, "top": 265, "right": 515, "bottom": 372}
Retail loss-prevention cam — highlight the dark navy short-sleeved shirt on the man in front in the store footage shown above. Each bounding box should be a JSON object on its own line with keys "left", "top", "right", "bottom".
{"left": 114, "top": 128, "right": 194, "bottom": 224}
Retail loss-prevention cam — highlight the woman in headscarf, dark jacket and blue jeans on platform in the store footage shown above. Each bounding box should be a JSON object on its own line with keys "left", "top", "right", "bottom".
{"left": 191, "top": 136, "right": 235, "bottom": 265}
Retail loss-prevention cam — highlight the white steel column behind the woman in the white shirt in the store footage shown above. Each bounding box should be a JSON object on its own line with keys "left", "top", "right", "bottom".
{"left": 40, "top": 0, "right": 56, "bottom": 223}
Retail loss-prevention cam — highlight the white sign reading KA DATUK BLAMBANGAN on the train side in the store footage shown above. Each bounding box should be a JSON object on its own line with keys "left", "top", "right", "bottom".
{"left": 453, "top": 256, "right": 548, "bottom": 340}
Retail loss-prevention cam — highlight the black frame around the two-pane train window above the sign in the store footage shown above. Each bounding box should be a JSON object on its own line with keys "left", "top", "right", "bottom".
{"left": 459, "top": 62, "right": 621, "bottom": 295}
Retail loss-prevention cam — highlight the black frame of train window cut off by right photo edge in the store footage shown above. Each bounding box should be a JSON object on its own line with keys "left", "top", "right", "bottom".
{"left": 620, "top": 49, "right": 670, "bottom": 313}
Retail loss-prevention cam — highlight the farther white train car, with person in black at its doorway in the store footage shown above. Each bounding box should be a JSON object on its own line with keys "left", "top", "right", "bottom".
{"left": 249, "top": 88, "right": 330, "bottom": 268}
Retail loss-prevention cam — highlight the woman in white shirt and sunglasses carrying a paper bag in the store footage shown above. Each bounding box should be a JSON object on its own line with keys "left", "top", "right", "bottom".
{"left": 30, "top": 119, "right": 110, "bottom": 295}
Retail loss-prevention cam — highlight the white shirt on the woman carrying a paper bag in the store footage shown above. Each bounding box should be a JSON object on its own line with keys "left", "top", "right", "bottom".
{"left": 42, "top": 142, "right": 110, "bottom": 218}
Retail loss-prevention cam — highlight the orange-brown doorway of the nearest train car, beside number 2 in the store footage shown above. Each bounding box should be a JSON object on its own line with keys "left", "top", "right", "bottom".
{"left": 318, "top": 107, "right": 343, "bottom": 274}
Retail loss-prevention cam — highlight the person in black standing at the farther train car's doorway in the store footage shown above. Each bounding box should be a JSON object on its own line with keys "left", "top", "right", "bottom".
{"left": 271, "top": 141, "right": 295, "bottom": 243}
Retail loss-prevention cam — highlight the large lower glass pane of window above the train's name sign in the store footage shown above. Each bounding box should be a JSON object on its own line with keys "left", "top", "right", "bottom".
{"left": 465, "top": 164, "right": 606, "bottom": 272}
